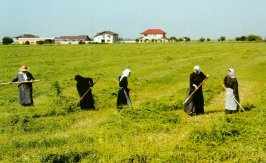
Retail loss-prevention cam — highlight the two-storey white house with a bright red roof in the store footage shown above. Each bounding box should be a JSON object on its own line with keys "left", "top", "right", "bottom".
{"left": 139, "top": 29, "right": 169, "bottom": 42}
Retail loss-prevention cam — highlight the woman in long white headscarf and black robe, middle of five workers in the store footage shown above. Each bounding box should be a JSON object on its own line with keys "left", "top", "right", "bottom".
{"left": 117, "top": 68, "right": 131, "bottom": 109}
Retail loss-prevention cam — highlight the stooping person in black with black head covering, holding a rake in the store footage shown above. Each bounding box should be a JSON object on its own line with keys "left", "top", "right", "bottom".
{"left": 75, "top": 75, "right": 95, "bottom": 110}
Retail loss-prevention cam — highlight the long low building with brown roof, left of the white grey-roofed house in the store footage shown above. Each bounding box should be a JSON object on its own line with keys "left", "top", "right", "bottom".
{"left": 55, "top": 35, "right": 91, "bottom": 44}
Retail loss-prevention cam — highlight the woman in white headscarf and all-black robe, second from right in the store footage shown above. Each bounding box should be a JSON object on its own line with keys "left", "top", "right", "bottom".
{"left": 185, "top": 66, "right": 209, "bottom": 115}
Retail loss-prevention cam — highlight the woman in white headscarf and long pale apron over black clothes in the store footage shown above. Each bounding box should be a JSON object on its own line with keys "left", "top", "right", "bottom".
{"left": 223, "top": 68, "right": 240, "bottom": 114}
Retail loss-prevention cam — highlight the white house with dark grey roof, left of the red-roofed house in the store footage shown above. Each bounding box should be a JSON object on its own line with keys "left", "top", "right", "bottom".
{"left": 93, "top": 31, "right": 118, "bottom": 43}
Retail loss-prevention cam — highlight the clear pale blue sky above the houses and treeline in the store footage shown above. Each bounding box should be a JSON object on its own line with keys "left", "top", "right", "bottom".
{"left": 0, "top": 0, "right": 266, "bottom": 39}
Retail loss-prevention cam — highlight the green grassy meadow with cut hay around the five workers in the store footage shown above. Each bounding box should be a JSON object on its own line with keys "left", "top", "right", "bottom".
{"left": 0, "top": 42, "right": 266, "bottom": 162}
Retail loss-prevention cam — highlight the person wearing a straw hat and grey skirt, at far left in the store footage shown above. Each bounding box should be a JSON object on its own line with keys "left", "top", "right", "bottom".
{"left": 11, "top": 66, "right": 34, "bottom": 106}
